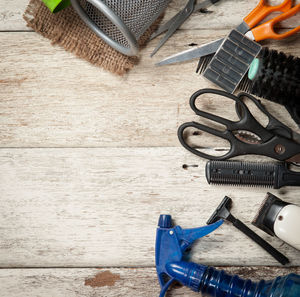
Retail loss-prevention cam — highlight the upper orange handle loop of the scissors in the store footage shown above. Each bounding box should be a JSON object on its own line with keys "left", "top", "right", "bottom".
{"left": 244, "top": 0, "right": 293, "bottom": 29}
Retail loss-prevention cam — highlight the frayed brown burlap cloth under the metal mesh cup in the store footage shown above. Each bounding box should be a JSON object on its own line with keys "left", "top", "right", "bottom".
{"left": 23, "top": 0, "right": 161, "bottom": 75}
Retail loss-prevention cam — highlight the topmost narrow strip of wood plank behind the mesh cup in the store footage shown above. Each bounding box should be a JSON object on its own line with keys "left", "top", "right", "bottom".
{"left": 0, "top": 0, "right": 299, "bottom": 31}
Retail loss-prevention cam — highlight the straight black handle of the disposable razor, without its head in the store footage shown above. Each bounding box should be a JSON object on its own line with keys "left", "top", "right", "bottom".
{"left": 227, "top": 215, "right": 289, "bottom": 265}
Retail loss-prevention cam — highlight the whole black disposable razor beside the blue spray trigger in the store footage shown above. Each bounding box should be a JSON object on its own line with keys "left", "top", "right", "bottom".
{"left": 206, "top": 196, "right": 289, "bottom": 265}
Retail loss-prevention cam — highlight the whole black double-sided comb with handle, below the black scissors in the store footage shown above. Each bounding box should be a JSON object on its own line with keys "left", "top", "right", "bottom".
{"left": 205, "top": 161, "right": 300, "bottom": 189}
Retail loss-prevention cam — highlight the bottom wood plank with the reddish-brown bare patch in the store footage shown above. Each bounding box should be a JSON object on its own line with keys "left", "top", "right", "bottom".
{"left": 0, "top": 267, "right": 300, "bottom": 297}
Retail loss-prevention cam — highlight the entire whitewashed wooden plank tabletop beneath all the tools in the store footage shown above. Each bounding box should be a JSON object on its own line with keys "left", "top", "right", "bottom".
{"left": 0, "top": 0, "right": 300, "bottom": 297}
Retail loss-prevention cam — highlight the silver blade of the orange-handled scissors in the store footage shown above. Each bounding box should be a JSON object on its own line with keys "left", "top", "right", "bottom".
{"left": 155, "top": 38, "right": 224, "bottom": 66}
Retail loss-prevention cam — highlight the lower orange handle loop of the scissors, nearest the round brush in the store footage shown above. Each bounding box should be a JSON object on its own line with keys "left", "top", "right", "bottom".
{"left": 251, "top": 4, "right": 300, "bottom": 41}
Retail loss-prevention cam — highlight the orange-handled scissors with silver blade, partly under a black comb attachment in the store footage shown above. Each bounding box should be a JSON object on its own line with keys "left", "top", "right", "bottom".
{"left": 156, "top": 0, "right": 300, "bottom": 66}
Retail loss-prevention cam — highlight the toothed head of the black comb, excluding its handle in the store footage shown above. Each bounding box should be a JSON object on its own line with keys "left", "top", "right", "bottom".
{"left": 206, "top": 161, "right": 278, "bottom": 188}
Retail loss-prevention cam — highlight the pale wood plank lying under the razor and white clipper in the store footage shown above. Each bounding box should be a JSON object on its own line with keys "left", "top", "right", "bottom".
{"left": 0, "top": 148, "right": 300, "bottom": 267}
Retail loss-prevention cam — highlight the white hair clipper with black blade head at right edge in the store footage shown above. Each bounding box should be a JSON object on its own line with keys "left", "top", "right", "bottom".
{"left": 252, "top": 193, "right": 300, "bottom": 250}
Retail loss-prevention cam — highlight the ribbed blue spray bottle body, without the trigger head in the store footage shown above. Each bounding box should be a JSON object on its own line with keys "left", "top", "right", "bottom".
{"left": 167, "top": 261, "right": 300, "bottom": 297}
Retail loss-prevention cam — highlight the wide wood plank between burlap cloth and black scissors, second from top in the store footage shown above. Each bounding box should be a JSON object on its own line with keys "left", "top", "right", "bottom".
{"left": 0, "top": 30, "right": 300, "bottom": 147}
